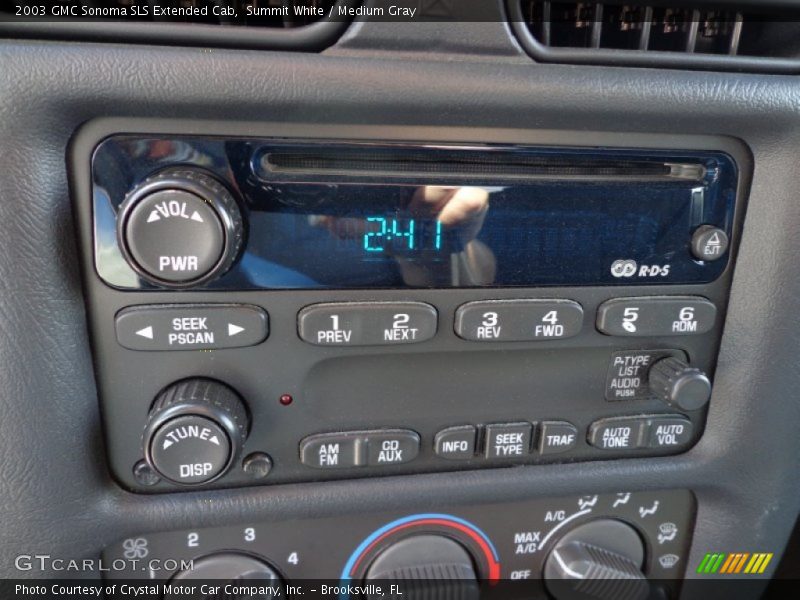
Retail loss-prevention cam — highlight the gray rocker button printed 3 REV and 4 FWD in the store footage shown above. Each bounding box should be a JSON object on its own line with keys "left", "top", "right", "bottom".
{"left": 455, "top": 300, "right": 583, "bottom": 342}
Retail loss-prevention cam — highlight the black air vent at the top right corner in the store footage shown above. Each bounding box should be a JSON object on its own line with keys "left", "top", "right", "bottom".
{"left": 508, "top": 0, "right": 800, "bottom": 72}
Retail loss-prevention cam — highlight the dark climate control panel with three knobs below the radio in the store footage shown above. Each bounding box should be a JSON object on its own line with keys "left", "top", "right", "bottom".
{"left": 103, "top": 490, "right": 695, "bottom": 600}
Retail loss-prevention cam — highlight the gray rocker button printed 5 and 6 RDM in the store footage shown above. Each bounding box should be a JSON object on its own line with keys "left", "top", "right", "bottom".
{"left": 597, "top": 296, "right": 717, "bottom": 337}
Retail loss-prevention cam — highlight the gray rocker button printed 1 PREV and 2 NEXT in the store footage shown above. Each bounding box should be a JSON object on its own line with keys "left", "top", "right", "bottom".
{"left": 297, "top": 302, "right": 437, "bottom": 346}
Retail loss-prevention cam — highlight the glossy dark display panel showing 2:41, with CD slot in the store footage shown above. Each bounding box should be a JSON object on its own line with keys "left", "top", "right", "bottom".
{"left": 94, "top": 136, "right": 737, "bottom": 289}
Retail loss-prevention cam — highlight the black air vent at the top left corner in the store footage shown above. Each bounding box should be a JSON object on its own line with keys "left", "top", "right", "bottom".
{"left": 0, "top": 0, "right": 360, "bottom": 51}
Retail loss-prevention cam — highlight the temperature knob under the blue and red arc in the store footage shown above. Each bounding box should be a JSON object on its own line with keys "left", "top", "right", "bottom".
{"left": 366, "top": 534, "right": 480, "bottom": 600}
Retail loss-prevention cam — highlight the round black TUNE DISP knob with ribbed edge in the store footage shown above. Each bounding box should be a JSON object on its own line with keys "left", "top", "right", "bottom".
{"left": 143, "top": 378, "right": 248, "bottom": 485}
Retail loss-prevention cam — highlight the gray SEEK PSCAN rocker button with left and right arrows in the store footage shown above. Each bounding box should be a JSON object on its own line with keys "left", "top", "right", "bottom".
{"left": 115, "top": 304, "right": 269, "bottom": 350}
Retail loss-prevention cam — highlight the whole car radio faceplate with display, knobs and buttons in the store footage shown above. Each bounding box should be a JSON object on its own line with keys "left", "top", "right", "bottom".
{"left": 79, "top": 135, "right": 742, "bottom": 491}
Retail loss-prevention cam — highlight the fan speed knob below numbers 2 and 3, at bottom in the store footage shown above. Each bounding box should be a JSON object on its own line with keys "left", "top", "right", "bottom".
{"left": 165, "top": 552, "right": 284, "bottom": 600}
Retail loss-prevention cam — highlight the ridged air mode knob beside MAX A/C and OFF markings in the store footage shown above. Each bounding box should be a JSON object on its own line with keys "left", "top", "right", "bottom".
{"left": 544, "top": 519, "right": 650, "bottom": 600}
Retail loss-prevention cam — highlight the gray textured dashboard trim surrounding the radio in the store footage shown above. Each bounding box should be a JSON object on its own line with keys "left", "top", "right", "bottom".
{"left": 0, "top": 12, "right": 800, "bottom": 597}
